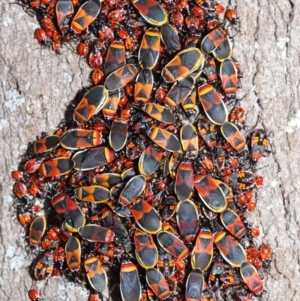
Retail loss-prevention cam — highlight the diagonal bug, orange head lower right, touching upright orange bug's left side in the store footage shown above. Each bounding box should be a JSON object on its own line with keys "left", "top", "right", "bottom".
{"left": 157, "top": 231, "right": 190, "bottom": 259}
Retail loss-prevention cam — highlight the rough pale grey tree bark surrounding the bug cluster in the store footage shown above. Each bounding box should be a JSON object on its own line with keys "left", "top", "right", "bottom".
{"left": 0, "top": 0, "right": 300, "bottom": 301}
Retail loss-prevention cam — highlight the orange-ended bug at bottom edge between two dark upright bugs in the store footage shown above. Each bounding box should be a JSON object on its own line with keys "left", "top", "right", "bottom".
{"left": 146, "top": 268, "right": 171, "bottom": 300}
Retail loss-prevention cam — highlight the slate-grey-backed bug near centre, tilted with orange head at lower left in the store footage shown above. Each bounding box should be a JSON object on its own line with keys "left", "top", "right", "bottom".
{"left": 118, "top": 175, "right": 146, "bottom": 206}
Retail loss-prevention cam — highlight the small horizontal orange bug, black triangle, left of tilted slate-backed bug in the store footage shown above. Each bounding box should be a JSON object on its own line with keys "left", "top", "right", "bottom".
{"left": 76, "top": 185, "right": 110, "bottom": 204}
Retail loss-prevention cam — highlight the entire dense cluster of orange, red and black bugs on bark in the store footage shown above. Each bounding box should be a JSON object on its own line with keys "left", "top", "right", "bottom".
{"left": 12, "top": 0, "right": 272, "bottom": 301}
